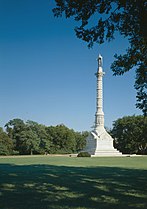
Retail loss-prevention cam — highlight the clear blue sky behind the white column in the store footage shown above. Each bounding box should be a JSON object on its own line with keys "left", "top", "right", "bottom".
{"left": 0, "top": 0, "right": 142, "bottom": 131}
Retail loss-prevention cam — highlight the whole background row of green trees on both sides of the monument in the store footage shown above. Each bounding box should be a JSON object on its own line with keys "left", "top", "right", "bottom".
{"left": 0, "top": 115, "right": 147, "bottom": 155}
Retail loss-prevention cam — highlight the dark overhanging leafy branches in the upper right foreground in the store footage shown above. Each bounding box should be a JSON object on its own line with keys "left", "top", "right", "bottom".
{"left": 53, "top": 0, "right": 147, "bottom": 115}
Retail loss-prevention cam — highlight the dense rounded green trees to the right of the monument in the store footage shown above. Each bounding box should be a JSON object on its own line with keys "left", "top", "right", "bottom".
{"left": 111, "top": 115, "right": 147, "bottom": 154}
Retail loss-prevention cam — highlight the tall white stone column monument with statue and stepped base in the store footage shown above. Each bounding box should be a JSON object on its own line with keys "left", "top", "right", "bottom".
{"left": 84, "top": 55, "right": 122, "bottom": 156}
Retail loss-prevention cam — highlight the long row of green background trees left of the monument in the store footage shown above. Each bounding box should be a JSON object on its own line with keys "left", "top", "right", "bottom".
{"left": 0, "top": 119, "right": 88, "bottom": 155}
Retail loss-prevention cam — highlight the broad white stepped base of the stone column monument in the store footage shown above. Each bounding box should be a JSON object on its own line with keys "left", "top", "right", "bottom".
{"left": 84, "top": 127, "right": 122, "bottom": 156}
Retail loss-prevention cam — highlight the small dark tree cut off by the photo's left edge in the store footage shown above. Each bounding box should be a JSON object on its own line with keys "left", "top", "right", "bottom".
{"left": 0, "top": 128, "right": 13, "bottom": 155}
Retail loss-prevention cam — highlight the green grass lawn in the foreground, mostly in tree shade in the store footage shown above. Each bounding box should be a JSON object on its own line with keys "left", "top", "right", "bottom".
{"left": 0, "top": 156, "right": 147, "bottom": 209}
